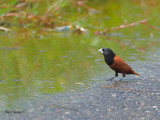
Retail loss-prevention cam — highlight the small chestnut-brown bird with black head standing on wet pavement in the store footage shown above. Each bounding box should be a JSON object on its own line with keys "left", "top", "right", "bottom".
{"left": 98, "top": 48, "right": 140, "bottom": 77}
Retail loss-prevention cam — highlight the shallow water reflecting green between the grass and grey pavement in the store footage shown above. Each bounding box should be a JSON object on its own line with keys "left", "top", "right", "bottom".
{"left": 0, "top": 31, "right": 159, "bottom": 109}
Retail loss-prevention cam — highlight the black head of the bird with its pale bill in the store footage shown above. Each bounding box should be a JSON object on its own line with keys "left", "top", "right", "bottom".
{"left": 99, "top": 48, "right": 116, "bottom": 65}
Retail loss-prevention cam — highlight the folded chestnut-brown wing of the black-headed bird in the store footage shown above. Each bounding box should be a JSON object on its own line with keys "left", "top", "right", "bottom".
{"left": 114, "top": 55, "right": 132, "bottom": 70}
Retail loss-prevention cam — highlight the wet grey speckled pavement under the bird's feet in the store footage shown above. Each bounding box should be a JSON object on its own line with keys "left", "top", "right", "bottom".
{"left": 1, "top": 62, "right": 160, "bottom": 120}
